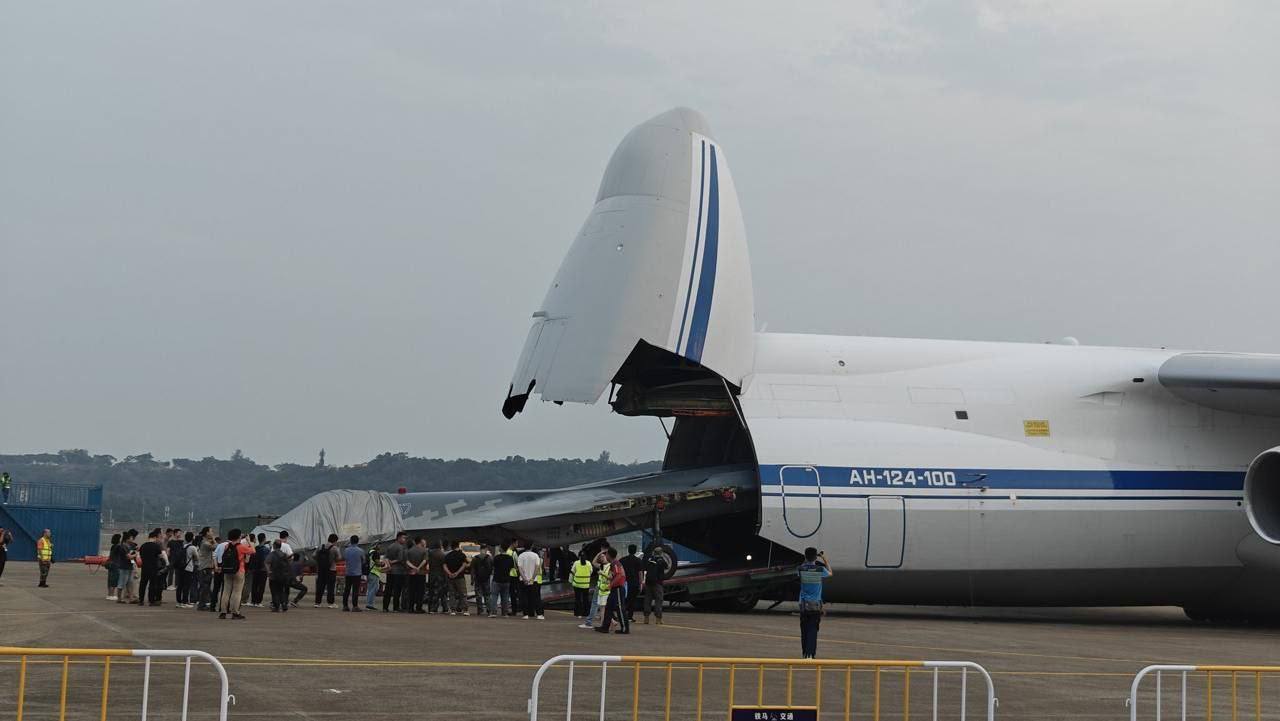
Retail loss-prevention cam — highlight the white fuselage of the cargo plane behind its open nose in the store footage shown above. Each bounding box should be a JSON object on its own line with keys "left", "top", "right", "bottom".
{"left": 741, "top": 333, "right": 1280, "bottom": 607}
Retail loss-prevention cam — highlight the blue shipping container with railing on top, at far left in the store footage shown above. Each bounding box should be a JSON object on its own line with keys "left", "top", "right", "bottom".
{"left": 0, "top": 483, "right": 102, "bottom": 561}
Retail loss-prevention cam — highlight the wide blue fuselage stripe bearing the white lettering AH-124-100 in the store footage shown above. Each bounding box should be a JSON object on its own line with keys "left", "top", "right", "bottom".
{"left": 760, "top": 464, "right": 1244, "bottom": 490}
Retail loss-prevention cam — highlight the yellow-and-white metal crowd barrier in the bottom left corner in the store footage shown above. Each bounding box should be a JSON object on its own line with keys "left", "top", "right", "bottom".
{"left": 0, "top": 645, "right": 236, "bottom": 721}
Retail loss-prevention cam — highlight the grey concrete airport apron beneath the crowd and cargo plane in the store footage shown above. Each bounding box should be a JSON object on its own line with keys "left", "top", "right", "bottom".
{"left": 0, "top": 562, "right": 1280, "bottom": 721}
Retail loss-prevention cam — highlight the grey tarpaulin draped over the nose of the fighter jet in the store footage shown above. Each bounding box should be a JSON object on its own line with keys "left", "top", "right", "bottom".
{"left": 253, "top": 490, "right": 404, "bottom": 549}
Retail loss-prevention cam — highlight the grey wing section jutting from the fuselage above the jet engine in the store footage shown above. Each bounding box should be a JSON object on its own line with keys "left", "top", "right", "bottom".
{"left": 1158, "top": 353, "right": 1280, "bottom": 416}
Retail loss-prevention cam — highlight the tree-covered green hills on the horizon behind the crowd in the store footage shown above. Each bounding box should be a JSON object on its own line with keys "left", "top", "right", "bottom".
{"left": 0, "top": 450, "right": 662, "bottom": 519}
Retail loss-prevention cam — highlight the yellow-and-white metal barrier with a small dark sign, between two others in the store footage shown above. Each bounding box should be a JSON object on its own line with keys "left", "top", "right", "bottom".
{"left": 529, "top": 654, "right": 998, "bottom": 721}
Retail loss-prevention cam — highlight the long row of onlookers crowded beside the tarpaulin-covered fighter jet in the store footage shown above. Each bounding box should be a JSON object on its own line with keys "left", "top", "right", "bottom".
{"left": 99, "top": 526, "right": 668, "bottom": 634}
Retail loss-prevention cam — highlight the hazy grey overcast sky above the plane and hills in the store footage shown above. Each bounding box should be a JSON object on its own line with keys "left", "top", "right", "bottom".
{"left": 0, "top": 0, "right": 1280, "bottom": 464}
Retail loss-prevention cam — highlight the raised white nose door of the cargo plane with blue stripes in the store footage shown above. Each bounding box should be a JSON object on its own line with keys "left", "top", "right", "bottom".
{"left": 502, "top": 108, "right": 754, "bottom": 417}
